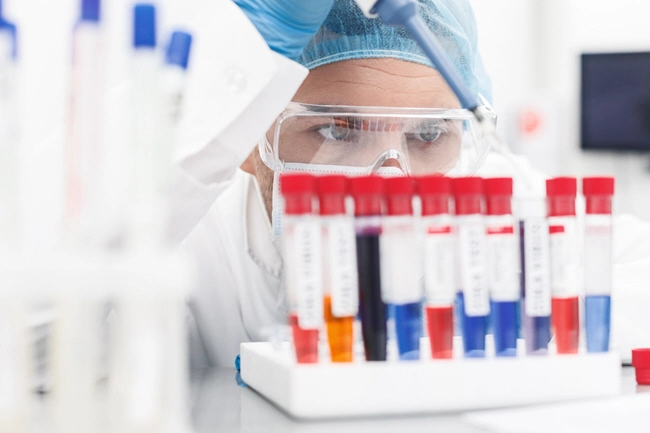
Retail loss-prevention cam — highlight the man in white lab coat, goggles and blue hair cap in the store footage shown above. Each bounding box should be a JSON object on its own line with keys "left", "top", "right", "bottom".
{"left": 175, "top": 0, "right": 650, "bottom": 366}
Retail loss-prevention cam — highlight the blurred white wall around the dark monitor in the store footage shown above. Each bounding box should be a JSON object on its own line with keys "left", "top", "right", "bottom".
{"left": 472, "top": 0, "right": 650, "bottom": 220}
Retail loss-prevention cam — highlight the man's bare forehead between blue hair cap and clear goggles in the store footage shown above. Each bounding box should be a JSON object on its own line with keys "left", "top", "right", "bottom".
{"left": 253, "top": 59, "right": 460, "bottom": 216}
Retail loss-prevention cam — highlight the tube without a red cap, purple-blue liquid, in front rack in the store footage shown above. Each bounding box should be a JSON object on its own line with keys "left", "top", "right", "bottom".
{"left": 516, "top": 197, "right": 551, "bottom": 355}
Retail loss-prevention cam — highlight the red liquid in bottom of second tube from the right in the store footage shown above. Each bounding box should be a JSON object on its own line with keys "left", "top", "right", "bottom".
{"left": 551, "top": 296, "right": 580, "bottom": 354}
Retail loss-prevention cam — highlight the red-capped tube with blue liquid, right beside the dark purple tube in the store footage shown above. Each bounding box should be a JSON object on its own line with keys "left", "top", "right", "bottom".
{"left": 380, "top": 177, "right": 422, "bottom": 360}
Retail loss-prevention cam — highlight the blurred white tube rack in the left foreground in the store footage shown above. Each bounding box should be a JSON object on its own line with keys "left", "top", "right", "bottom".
{"left": 0, "top": 251, "right": 194, "bottom": 433}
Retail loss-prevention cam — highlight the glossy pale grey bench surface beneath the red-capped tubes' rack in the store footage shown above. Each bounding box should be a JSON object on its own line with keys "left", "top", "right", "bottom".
{"left": 191, "top": 367, "right": 650, "bottom": 433}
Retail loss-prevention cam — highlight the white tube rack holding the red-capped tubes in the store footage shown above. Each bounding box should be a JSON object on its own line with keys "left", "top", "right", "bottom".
{"left": 241, "top": 339, "right": 621, "bottom": 420}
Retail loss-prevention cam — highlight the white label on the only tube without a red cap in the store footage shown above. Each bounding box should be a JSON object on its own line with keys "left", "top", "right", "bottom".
{"left": 524, "top": 218, "right": 551, "bottom": 317}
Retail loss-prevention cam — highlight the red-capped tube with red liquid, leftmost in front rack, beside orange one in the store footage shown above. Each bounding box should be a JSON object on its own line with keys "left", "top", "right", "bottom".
{"left": 280, "top": 174, "right": 323, "bottom": 364}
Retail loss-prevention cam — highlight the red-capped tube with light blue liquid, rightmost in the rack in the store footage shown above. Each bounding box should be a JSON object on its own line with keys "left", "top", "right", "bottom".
{"left": 582, "top": 177, "right": 614, "bottom": 352}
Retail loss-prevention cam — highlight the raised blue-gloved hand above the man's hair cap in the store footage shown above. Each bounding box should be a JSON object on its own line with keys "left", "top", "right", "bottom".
{"left": 234, "top": 0, "right": 334, "bottom": 60}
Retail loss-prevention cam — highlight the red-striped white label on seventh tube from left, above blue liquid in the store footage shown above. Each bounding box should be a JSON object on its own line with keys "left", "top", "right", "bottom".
{"left": 487, "top": 226, "right": 520, "bottom": 302}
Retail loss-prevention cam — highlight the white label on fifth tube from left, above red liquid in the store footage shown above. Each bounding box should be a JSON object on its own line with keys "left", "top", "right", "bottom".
{"left": 424, "top": 226, "right": 456, "bottom": 305}
